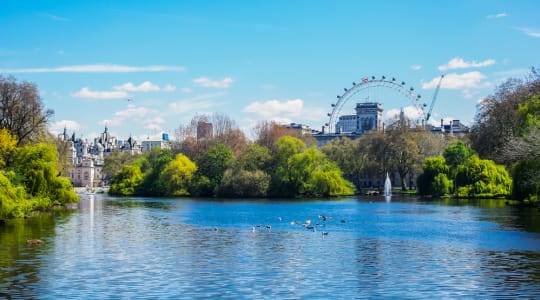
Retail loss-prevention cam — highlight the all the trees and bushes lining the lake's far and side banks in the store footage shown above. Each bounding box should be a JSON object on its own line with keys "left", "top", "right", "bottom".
{"left": 0, "top": 64, "right": 540, "bottom": 220}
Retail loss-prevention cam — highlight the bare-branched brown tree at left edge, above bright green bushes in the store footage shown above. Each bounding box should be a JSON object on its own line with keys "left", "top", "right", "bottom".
{"left": 0, "top": 76, "right": 54, "bottom": 145}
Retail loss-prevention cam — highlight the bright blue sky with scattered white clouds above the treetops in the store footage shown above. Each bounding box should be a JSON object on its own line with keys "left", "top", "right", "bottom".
{"left": 0, "top": 0, "right": 540, "bottom": 141}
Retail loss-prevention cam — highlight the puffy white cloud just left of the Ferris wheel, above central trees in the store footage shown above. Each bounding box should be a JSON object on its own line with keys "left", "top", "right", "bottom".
{"left": 243, "top": 99, "right": 304, "bottom": 123}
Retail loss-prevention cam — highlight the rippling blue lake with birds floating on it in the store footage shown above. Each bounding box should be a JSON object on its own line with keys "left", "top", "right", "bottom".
{"left": 0, "top": 194, "right": 540, "bottom": 299}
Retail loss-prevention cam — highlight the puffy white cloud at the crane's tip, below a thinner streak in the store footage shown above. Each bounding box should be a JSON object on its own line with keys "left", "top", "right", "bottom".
{"left": 422, "top": 71, "right": 491, "bottom": 90}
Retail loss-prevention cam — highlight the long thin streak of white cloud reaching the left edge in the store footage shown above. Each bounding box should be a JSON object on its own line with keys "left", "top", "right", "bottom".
{"left": 0, "top": 64, "right": 186, "bottom": 73}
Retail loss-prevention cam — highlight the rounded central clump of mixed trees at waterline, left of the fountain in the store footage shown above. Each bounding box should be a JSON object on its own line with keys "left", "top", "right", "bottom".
{"left": 109, "top": 114, "right": 355, "bottom": 198}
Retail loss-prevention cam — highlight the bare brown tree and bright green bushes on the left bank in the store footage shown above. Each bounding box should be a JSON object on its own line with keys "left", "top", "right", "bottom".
{"left": 0, "top": 76, "right": 79, "bottom": 220}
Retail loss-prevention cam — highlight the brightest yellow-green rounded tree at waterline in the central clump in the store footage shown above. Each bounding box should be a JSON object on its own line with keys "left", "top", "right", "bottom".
{"left": 159, "top": 154, "right": 197, "bottom": 196}
